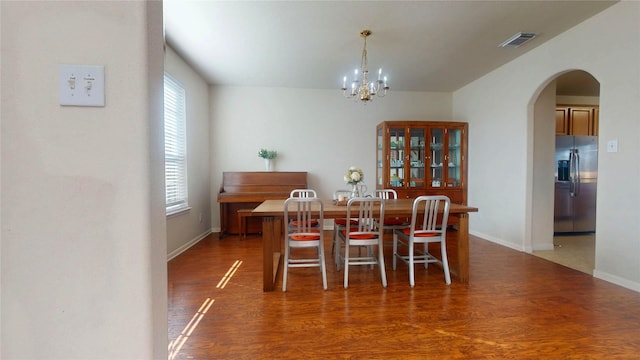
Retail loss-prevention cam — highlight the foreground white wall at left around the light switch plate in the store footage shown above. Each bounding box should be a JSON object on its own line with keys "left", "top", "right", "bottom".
{"left": 0, "top": 1, "right": 167, "bottom": 359}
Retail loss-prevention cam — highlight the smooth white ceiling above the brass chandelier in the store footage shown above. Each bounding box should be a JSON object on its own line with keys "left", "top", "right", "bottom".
{"left": 164, "top": 0, "right": 616, "bottom": 92}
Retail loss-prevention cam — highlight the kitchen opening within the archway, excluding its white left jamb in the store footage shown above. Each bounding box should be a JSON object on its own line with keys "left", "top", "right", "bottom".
{"left": 532, "top": 70, "right": 600, "bottom": 275}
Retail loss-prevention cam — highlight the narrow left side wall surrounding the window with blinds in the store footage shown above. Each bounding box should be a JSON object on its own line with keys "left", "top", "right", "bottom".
{"left": 165, "top": 46, "right": 212, "bottom": 258}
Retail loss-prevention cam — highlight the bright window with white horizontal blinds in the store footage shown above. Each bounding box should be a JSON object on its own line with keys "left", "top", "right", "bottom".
{"left": 164, "top": 73, "right": 189, "bottom": 215}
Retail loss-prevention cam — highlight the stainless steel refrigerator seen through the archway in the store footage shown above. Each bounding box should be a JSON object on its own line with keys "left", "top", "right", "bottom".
{"left": 553, "top": 136, "right": 598, "bottom": 233}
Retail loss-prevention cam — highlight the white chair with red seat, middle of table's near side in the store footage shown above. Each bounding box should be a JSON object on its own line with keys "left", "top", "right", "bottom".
{"left": 336, "top": 197, "right": 387, "bottom": 289}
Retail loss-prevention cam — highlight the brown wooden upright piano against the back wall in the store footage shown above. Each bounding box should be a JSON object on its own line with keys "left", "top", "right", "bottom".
{"left": 218, "top": 171, "right": 307, "bottom": 238}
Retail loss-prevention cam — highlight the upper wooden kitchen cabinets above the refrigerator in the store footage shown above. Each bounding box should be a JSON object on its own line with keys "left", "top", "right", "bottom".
{"left": 556, "top": 105, "right": 599, "bottom": 135}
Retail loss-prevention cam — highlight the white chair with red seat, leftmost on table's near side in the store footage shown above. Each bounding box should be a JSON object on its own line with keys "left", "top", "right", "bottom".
{"left": 282, "top": 197, "right": 327, "bottom": 292}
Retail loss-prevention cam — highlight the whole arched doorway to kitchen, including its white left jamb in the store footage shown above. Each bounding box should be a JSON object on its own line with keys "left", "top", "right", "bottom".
{"left": 532, "top": 70, "right": 600, "bottom": 274}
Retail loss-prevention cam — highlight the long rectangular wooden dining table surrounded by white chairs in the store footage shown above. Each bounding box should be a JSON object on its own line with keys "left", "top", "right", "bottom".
{"left": 251, "top": 199, "right": 478, "bottom": 292}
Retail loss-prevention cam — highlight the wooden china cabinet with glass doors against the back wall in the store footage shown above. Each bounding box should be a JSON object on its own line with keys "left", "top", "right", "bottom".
{"left": 376, "top": 121, "right": 468, "bottom": 204}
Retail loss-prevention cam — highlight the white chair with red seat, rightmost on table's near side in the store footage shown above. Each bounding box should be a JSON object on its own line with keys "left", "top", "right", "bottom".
{"left": 392, "top": 195, "right": 451, "bottom": 287}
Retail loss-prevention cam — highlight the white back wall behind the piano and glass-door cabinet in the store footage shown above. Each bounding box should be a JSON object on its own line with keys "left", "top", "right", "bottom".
{"left": 211, "top": 87, "right": 453, "bottom": 231}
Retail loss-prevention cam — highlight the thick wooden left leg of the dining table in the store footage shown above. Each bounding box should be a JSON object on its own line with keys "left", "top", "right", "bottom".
{"left": 262, "top": 216, "right": 282, "bottom": 292}
